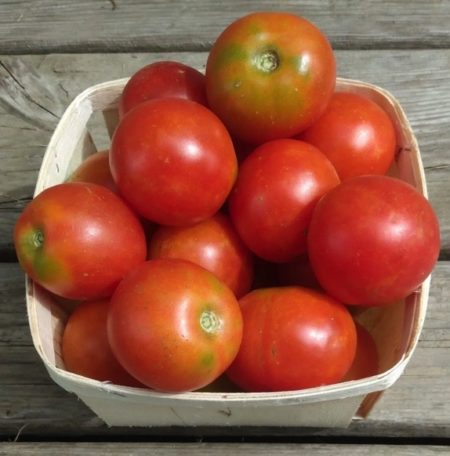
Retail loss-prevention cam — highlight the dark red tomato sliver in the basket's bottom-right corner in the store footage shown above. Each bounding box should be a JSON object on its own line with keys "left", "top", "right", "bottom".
{"left": 342, "top": 322, "right": 379, "bottom": 382}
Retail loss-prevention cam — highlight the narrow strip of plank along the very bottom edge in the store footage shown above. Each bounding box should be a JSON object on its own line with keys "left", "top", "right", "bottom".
{"left": 0, "top": 442, "right": 448, "bottom": 456}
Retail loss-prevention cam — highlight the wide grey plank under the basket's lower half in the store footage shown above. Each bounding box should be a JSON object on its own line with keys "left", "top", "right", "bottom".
{"left": 0, "top": 262, "right": 450, "bottom": 440}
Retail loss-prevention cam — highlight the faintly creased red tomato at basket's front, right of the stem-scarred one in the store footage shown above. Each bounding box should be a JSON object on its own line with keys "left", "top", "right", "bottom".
{"left": 227, "top": 287, "right": 356, "bottom": 391}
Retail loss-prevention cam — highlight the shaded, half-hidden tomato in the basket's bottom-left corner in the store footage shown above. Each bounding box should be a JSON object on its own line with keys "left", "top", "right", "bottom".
{"left": 61, "top": 299, "right": 141, "bottom": 386}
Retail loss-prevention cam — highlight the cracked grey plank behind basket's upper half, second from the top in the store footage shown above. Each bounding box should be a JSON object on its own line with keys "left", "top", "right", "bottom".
{"left": 0, "top": 49, "right": 450, "bottom": 261}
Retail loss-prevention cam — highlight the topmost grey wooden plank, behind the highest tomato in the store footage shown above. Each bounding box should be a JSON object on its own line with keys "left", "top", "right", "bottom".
{"left": 0, "top": 0, "right": 450, "bottom": 54}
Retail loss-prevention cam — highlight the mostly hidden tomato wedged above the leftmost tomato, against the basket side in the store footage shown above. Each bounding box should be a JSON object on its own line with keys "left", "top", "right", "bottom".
{"left": 67, "top": 150, "right": 117, "bottom": 193}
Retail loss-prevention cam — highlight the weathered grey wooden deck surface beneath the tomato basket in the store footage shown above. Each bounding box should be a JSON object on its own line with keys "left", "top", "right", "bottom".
{"left": 0, "top": 0, "right": 450, "bottom": 456}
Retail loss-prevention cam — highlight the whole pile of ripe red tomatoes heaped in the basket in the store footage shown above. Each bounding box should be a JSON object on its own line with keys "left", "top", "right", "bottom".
{"left": 14, "top": 13, "right": 439, "bottom": 392}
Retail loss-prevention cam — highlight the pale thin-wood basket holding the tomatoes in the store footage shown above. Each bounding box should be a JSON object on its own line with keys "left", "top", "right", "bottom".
{"left": 26, "top": 79, "right": 430, "bottom": 427}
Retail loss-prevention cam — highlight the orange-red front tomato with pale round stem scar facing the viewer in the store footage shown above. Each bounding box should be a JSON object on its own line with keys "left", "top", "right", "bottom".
{"left": 108, "top": 259, "right": 242, "bottom": 392}
